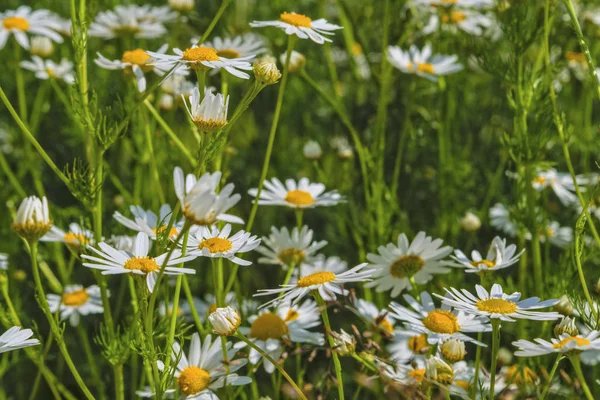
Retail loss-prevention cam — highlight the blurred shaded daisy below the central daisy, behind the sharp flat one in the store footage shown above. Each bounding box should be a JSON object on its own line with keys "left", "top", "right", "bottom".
{"left": 256, "top": 225, "right": 327, "bottom": 266}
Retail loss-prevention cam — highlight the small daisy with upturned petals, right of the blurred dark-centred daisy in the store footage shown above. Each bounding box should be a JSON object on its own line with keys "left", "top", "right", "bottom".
{"left": 452, "top": 236, "right": 525, "bottom": 273}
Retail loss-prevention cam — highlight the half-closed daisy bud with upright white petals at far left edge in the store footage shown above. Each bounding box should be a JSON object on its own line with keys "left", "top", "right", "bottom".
{"left": 11, "top": 196, "right": 52, "bottom": 241}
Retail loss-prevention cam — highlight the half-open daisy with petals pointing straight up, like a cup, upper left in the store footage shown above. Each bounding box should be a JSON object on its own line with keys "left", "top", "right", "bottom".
{"left": 181, "top": 87, "right": 229, "bottom": 133}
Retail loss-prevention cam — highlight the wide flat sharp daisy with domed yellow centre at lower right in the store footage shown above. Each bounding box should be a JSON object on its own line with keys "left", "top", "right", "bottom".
{"left": 436, "top": 283, "right": 561, "bottom": 322}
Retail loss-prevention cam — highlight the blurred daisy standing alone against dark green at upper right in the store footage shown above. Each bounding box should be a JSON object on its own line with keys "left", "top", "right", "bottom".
{"left": 387, "top": 44, "right": 463, "bottom": 82}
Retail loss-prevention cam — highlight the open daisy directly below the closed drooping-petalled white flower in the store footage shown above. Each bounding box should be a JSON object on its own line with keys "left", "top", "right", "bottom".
{"left": 182, "top": 224, "right": 260, "bottom": 266}
